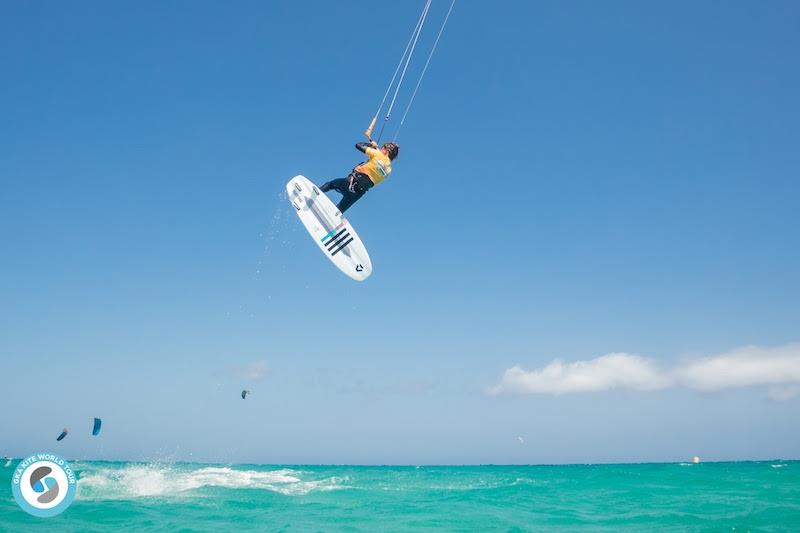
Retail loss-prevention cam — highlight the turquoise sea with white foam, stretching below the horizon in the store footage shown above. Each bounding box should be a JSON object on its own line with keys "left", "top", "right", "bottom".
{"left": 0, "top": 461, "right": 800, "bottom": 532}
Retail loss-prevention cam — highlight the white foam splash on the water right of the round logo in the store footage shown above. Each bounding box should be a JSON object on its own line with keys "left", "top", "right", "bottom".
{"left": 78, "top": 464, "right": 347, "bottom": 500}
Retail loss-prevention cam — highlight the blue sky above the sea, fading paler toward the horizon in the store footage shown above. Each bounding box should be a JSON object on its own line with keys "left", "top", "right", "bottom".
{"left": 0, "top": 1, "right": 800, "bottom": 463}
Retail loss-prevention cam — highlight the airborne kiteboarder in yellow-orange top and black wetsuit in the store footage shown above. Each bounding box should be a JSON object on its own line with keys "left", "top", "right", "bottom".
{"left": 320, "top": 139, "right": 400, "bottom": 213}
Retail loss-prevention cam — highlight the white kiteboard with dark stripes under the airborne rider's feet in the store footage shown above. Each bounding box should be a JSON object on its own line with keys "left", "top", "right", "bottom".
{"left": 286, "top": 176, "right": 372, "bottom": 281}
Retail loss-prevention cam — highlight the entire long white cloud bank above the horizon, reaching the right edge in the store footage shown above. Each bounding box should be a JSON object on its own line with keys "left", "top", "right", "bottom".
{"left": 487, "top": 344, "right": 800, "bottom": 401}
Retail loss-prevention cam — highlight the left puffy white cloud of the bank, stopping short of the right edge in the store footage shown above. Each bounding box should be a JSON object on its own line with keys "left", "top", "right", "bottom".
{"left": 489, "top": 353, "right": 670, "bottom": 394}
